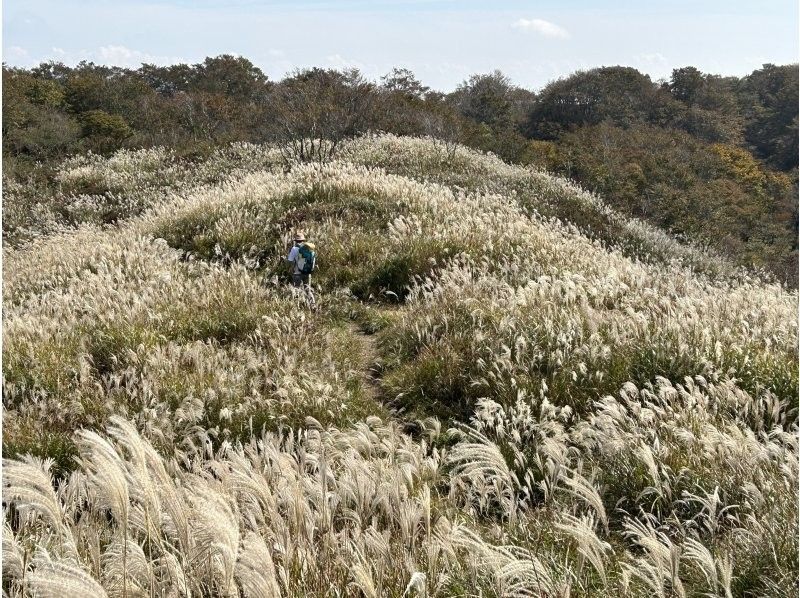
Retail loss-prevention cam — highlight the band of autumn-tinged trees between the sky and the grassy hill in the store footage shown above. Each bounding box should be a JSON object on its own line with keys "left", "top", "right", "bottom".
{"left": 3, "top": 55, "right": 798, "bottom": 285}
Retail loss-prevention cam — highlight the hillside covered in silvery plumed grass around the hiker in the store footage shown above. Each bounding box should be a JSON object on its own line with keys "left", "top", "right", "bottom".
{"left": 3, "top": 135, "right": 798, "bottom": 597}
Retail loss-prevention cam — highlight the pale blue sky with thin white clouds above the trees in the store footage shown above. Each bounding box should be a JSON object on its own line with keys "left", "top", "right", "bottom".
{"left": 2, "top": 0, "right": 800, "bottom": 91}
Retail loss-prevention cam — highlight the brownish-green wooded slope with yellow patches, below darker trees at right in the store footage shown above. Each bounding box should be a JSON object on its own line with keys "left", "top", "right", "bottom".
{"left": 540, "top": 124, "right": 797, "bottom": 285}
